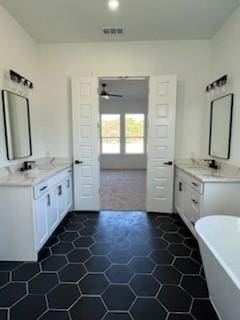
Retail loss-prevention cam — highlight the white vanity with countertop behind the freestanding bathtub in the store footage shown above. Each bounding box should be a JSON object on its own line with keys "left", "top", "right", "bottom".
{"left": 174, "top": 164, "right": 240, "bottom": 235}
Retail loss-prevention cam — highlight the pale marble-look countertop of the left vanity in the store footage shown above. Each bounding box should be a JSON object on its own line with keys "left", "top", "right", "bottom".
{"left": 0, "top": 161, "right": 72, "bottom": 187}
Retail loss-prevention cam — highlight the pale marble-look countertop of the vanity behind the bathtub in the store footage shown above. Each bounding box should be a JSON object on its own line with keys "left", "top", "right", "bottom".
{"left": 176, "top": 163, "right": 240, "bottom": 182}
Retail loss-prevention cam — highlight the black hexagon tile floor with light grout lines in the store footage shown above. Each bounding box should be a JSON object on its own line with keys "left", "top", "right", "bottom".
{"left": 0, "top": 211, "right": 218, "bottom": 320}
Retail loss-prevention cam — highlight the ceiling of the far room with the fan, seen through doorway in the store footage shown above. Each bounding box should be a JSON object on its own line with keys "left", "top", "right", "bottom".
{"left": 100, "top": 78, "right": 148, "bottom": 100}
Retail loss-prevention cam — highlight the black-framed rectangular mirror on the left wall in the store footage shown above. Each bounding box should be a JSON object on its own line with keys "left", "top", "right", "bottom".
{"left": 2, "top": 90, "right": 32, "bottom": 160}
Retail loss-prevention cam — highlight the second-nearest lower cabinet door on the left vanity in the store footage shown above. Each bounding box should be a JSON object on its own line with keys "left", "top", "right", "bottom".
{"left": 46, "top": 190, "right": 58, "bottom": 235}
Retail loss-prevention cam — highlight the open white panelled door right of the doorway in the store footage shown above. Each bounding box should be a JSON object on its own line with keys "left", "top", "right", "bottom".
{"left": 147, "top": 75, "right": 177, "bottom": 213}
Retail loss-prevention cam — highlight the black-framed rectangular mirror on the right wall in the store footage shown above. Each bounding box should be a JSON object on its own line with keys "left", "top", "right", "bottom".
{"left": 209, "top": 94, "right": 233, "bottom": 159}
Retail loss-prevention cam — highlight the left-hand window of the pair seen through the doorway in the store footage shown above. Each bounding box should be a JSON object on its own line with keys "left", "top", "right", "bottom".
{"left": 101, "top": 114, "right": 120, "bottom": 154}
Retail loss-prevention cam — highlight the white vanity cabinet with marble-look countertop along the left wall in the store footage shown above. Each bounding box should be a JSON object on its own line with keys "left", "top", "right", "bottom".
{"left": 0, "top": 163, "right": 72, "bottom": 261}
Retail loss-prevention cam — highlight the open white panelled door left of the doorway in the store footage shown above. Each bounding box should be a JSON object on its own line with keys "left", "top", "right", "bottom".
{"left": 72, "top": 77, "right": 100, "bottom": 211}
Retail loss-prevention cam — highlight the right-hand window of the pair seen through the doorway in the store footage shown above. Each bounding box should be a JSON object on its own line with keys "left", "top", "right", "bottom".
{"left": 125, "top": 114, "right": 145, "bottom": 154}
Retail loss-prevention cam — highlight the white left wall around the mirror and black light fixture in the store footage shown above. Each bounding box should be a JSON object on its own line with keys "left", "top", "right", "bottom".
{"left": 0, "top": 6, "right": 45, "bottom": 168}
